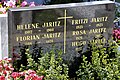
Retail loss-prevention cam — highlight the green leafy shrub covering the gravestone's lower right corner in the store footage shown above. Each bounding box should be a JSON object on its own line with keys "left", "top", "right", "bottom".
{"left": 76, "top": 42, "right": 120, "bottom": 80}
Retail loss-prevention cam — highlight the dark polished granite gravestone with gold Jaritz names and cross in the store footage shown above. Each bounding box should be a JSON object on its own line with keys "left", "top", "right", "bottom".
{"left": 8, "top": 1, "right": 115, "bottom": 77}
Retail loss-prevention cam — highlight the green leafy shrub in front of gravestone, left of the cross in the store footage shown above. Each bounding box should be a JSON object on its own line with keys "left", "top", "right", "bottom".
{"left": 19, "top": 46, "right": 69, "bottom": 80}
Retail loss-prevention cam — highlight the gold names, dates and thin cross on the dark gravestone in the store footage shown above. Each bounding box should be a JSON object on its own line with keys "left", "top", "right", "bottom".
{"left": 12, "top": 9, "right": 109, "bottom": 53}
